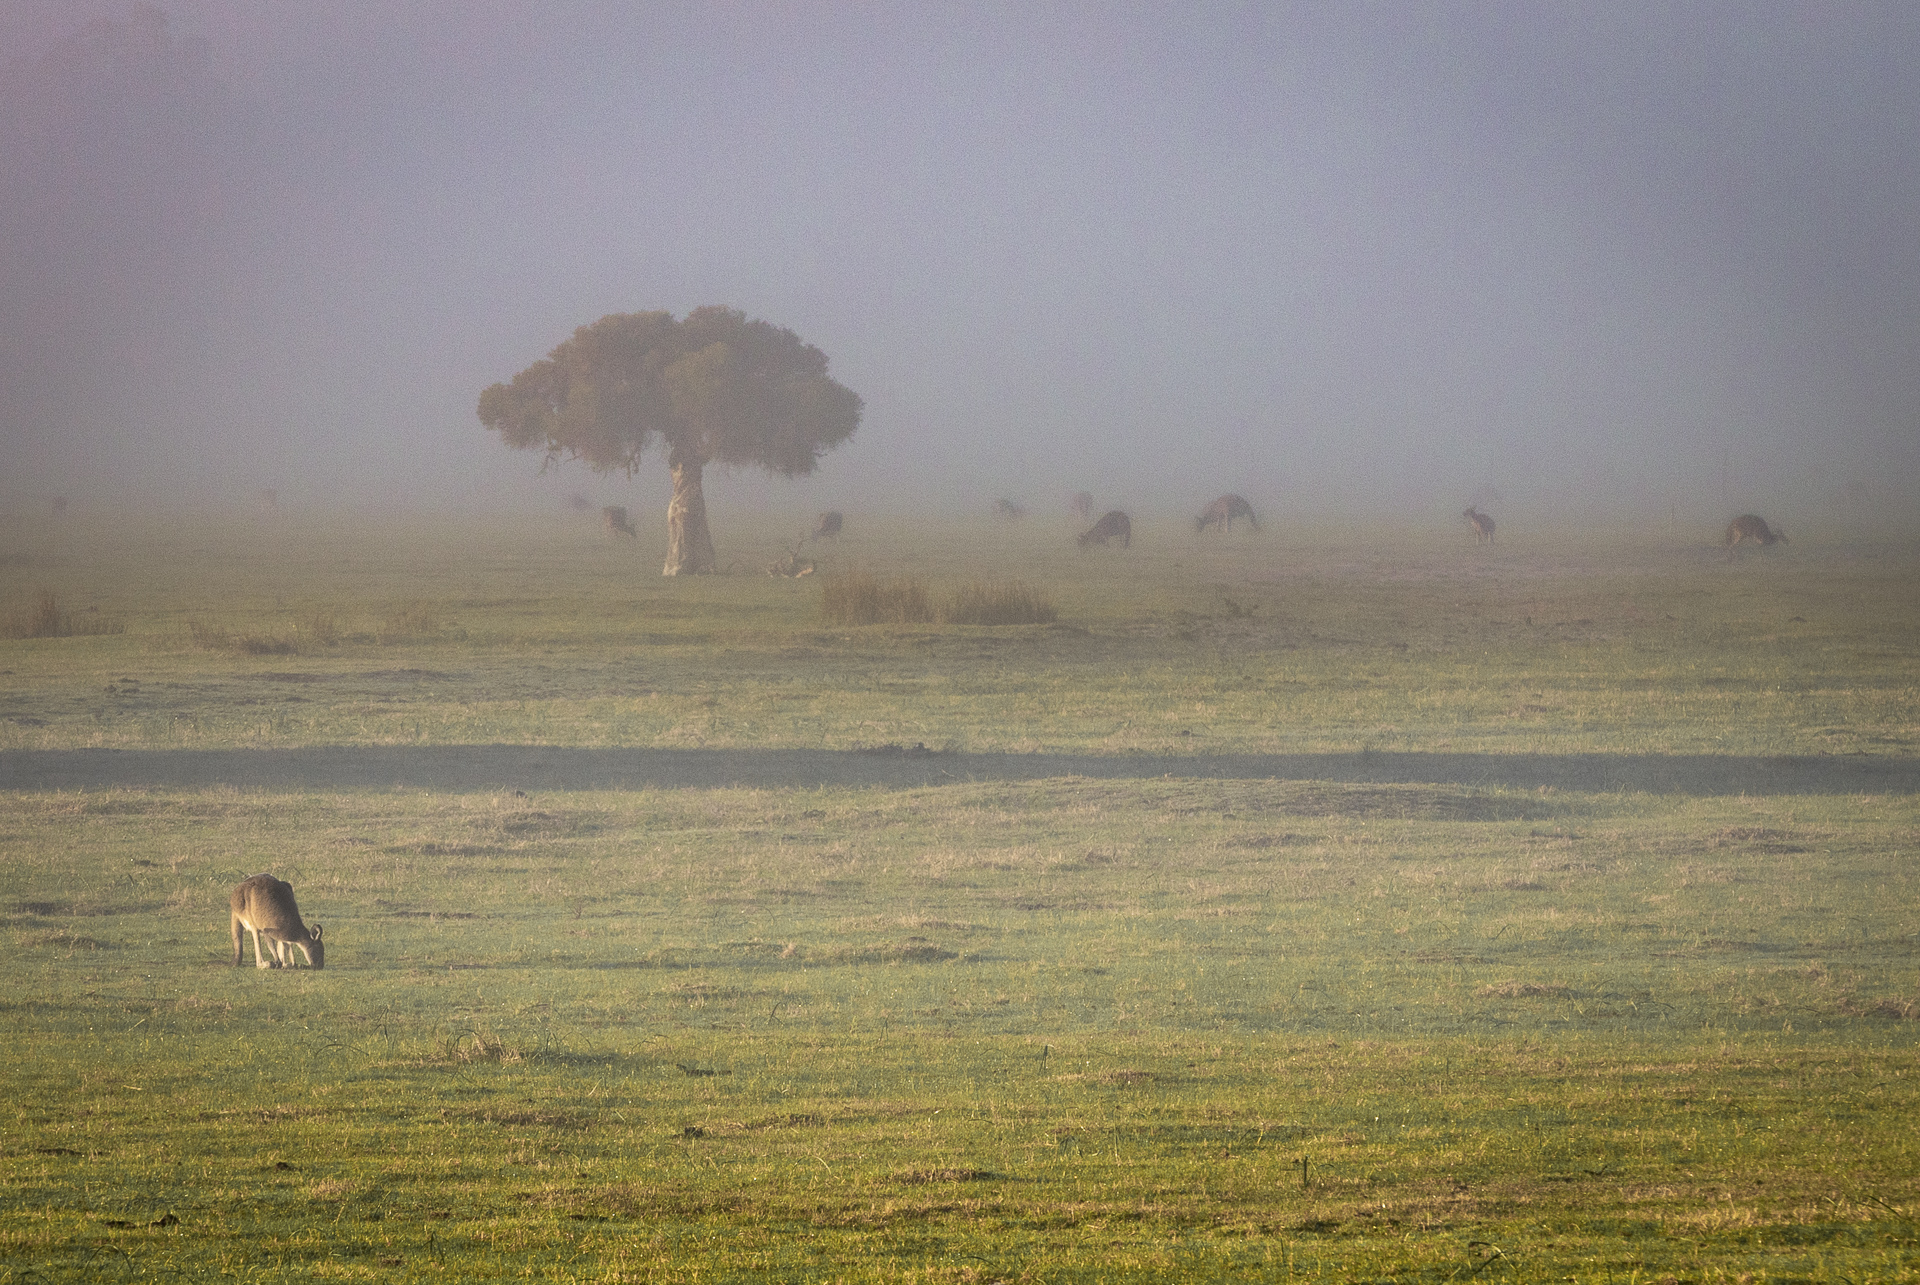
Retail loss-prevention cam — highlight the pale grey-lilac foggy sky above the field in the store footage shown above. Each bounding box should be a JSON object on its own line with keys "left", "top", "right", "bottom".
{"left": 0, "top": 0, "right": 1920, "bottom": 526}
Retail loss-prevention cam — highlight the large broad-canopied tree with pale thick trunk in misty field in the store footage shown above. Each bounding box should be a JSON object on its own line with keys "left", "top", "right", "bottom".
{"left": 480, "top": 307, "right": 860, "bottom": 576}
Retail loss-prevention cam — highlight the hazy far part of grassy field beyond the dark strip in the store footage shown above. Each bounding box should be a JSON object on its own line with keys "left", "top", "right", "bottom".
{"left": 0, "top": 519, "right": 1920, "bottom": 755}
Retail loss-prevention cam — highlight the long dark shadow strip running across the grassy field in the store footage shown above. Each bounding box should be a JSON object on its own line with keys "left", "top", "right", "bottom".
{"left": 0, "top": 745, "right": 1920, "bottom": 795}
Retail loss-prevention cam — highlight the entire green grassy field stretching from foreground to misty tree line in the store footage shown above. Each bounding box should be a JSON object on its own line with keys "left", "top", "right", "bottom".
{"left": 0, "top": 519, "right": 1920, "bottom": 1283}
